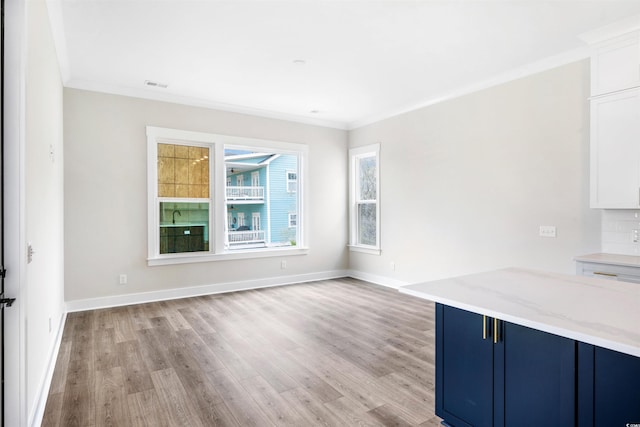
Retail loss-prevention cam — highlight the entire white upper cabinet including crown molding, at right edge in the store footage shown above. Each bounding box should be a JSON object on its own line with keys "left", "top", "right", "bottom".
{"left": 582, "top": 16, "right": 640, "bottom": 209}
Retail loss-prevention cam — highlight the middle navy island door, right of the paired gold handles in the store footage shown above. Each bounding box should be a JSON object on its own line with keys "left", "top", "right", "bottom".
{"left": 502, "top": 323, "right": 576, "bottom": 427}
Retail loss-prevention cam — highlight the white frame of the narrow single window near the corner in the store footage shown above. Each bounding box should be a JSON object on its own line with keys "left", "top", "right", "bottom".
{"left": 349, "top": 143, "right": 382, "bottom": 255}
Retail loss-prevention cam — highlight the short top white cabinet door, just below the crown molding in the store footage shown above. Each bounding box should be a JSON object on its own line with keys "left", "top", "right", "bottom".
{"left": 591, "top": 31, "right": 640, "bottom": 96}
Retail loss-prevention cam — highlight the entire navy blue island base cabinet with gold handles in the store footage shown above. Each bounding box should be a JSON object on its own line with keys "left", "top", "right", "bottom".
{"left": 436, "top": 303, "right": 640, "bottom": 427}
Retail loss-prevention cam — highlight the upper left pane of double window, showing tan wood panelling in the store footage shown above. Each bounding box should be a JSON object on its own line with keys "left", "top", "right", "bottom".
{"left": 158, "top": 144, "right": 210, "bottom": 199}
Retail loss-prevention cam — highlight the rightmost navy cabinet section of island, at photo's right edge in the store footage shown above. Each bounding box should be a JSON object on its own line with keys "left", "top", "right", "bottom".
{"left": 578, "top": 343, "right": 640, "bottom": 427}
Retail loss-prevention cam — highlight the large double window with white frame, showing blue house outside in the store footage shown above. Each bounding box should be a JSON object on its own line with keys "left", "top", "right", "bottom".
{"left": 147, "top": 127, "right": 307, "bottom": 265}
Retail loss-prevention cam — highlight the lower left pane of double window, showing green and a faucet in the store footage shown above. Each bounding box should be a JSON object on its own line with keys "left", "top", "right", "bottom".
{"left": 160, "top": 202, "right": 209, "bottom": 254}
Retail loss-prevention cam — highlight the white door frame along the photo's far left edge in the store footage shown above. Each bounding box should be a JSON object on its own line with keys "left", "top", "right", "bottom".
{"left": 2, "top": 0, "right": 28, "bottom": 427}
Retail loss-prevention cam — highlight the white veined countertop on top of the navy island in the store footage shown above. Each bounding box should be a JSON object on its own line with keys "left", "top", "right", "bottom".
{"left": 400, "top": 268, "right": 640, "bottom": 357}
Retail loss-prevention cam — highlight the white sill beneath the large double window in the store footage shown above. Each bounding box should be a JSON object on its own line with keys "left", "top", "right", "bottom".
{"left": 147, "top": 248, "right": 309, "bottom": 267}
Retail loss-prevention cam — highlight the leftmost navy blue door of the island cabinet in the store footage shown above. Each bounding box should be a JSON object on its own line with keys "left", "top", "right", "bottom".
{"left": 436, "top": 304, "right": 494, "bottom": 427}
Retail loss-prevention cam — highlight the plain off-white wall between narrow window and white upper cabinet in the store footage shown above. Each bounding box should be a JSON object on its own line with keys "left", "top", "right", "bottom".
{"left": 349, "top": 60, "right": 600, "bottom": 282}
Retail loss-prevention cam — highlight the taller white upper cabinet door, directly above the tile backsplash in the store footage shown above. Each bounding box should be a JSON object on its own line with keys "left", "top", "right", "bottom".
{"left": 591, "top": 89, "right": 640, "bottom": 209}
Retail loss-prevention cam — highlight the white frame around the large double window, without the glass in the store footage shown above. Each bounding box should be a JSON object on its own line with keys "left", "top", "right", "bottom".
{"left": 146, "top": 126, "right": 309, "bottom": 266}
